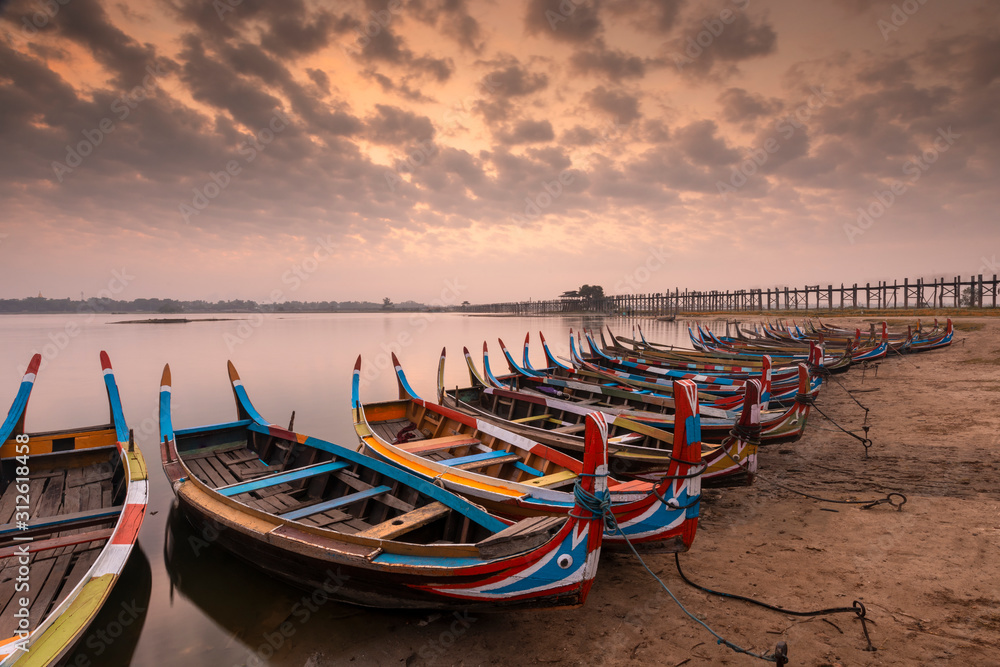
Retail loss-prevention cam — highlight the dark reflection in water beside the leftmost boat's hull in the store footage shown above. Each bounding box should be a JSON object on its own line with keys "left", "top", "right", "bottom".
{"left": 63, "top": 545, "right": 153, "bottom": 667}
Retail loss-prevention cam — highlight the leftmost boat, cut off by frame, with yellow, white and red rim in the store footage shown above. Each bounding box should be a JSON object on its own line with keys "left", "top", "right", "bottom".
{"left": 0, "top": 352, "right": 147, "bottom": 666}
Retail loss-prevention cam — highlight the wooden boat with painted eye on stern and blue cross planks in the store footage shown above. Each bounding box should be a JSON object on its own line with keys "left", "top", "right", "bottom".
{"left": 160, "top": 363, "right": 607, "bottom": 611}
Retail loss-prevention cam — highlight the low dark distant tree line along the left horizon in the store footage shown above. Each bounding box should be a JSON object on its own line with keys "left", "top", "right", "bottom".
{"left": 0, "top": 296, "right": 428, "bottom": 313}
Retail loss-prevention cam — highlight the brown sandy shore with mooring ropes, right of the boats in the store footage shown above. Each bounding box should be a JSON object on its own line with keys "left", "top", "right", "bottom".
{"left": 288, "top": 318, "right": 1000, "bottom": 667}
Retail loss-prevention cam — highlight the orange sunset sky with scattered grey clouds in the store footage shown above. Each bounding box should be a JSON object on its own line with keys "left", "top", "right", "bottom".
{"left": 0, "top": 0, "right": 1000, "bottom": 305}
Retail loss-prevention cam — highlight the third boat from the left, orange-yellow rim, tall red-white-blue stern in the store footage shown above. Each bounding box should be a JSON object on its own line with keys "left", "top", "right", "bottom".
{"left": 351, "top": 355, "right": 704, "bottom": 551}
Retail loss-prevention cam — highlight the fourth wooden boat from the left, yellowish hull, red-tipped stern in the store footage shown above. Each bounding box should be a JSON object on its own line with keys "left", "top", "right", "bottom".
{"left": 438, "top": 348, "right": 761, "bottom": 486}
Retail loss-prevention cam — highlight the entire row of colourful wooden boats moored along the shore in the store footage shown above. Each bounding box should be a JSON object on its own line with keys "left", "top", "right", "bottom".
{"left": 0, "top": 320, "right": 953, "bottom": 665}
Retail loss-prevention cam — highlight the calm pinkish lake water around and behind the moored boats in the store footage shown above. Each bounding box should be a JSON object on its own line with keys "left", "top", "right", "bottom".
{"left": 0, "top": 314, "right": 686, "bottom": 667}
